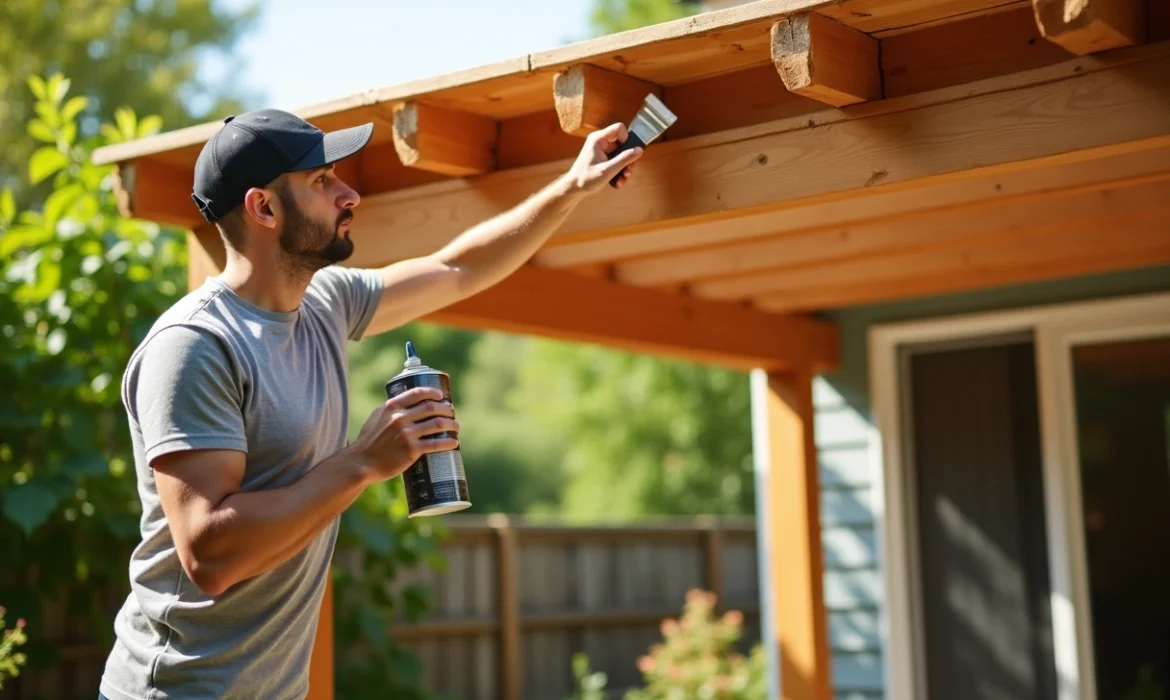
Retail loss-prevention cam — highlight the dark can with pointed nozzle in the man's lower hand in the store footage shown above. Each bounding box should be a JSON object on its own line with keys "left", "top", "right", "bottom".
{"left": 386, "top": 342, "right": 472, "bottom": 517}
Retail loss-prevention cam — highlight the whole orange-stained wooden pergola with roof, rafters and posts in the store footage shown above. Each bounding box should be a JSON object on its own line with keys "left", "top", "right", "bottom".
{"left": 96, "top": 0, "right": 1170, "bottom": 700}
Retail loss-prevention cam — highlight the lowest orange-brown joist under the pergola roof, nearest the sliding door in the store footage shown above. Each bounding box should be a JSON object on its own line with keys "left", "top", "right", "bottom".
{"left": 752, "top": 212, "right": 1170, "bottom": 313}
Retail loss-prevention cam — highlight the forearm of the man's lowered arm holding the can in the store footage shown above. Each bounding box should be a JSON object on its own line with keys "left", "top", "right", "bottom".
{"left": 192, "top": 448, "right": 369, "bottom": 595}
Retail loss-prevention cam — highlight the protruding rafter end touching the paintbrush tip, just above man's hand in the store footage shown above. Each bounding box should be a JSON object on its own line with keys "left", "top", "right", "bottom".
{"left": 552, "top": 63, "right": 662, "bottom": 136}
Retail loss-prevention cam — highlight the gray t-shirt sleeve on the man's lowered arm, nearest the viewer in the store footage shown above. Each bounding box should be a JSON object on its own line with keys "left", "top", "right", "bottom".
{"left": 126, "top": 327, "right": 248, "bottom": 462}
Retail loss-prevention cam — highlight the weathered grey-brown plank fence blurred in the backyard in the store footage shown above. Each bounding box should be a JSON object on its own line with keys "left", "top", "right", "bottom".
{"left": 0, "top": 516, "right": 759, "bottom": 700}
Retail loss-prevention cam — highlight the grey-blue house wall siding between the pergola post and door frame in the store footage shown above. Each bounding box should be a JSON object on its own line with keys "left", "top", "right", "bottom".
{"left": 813, "top": 266, "right": 1170, "bottom": 700}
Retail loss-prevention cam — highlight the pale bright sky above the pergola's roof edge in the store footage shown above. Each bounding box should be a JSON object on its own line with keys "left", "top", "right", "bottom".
{"left": 202, "top": 0, "right": 592, "bottom": 109}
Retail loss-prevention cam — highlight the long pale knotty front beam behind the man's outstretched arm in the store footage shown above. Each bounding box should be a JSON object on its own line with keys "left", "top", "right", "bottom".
{"left": 341, "top": 44, "right": 1170, "bottom": 267}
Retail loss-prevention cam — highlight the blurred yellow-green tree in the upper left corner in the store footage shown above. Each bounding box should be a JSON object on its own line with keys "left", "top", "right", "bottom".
{"left": 0, "top": 0, "right": 256, "bottom": 204}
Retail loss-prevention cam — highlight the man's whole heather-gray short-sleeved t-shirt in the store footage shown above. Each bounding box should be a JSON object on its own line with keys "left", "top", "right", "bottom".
{"left": 101, "top": 267, "right": 380, "bottom": 700}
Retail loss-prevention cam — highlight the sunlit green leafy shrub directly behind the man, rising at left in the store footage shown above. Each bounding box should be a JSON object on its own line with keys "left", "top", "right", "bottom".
{"left": 0, "top": 75, "right": 441, "bottom": 699}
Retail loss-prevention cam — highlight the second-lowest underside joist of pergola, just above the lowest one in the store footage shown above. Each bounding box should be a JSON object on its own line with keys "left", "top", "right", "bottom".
{"left": 614, "top": 176, "right": 1170, "bottom": 289}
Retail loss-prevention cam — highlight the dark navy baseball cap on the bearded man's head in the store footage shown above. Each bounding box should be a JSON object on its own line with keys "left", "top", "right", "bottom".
{"left": 191, "top": 109, "right": 373, "bottom": 221}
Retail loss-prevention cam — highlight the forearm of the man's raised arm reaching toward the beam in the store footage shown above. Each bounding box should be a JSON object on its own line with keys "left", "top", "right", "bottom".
{"left": 434, "top": 174, "right": 584, "bottom": 295}
